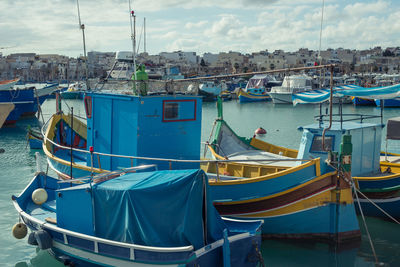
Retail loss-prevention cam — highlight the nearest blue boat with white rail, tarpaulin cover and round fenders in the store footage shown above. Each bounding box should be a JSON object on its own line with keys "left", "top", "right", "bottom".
{"left": 12, "top": 169, "right": 262, "bottom": 267}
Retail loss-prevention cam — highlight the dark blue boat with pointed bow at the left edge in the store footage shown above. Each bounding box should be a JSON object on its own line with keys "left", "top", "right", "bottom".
{"left": 0, "top": 84, "right": 57, "bottom": 125}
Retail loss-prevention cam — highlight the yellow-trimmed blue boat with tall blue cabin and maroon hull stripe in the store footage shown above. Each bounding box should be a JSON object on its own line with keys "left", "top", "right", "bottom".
{"left": 43, "top": 93, "right": 360, "bottom": 245}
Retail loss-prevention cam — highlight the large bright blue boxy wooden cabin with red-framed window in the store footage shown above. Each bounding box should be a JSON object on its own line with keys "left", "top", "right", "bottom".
{"left": 84, "top": 93, "right": 202, "bottom": 170}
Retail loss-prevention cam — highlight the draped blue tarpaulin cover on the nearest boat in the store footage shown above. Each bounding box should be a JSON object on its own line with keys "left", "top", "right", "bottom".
{"left": 93, "top": 170, "right": 226, "bottom": 249}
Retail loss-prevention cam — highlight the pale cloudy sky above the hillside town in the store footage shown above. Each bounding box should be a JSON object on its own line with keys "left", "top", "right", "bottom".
{"left": 0, "top": 0, "right": 400, "bottom": 57}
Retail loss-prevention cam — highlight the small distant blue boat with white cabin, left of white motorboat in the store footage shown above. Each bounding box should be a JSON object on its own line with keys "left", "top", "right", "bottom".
{"left": 238, "top": 74, "right": 281, "bottom": 103}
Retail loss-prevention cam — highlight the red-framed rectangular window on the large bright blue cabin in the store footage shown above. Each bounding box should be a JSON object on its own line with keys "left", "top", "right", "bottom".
{"left": 163, "top": 99, "right": 197, "bottom": 122}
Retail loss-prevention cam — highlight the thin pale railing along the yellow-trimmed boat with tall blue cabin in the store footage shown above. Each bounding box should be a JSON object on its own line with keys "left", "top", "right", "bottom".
{"left": 41, "top": 116, "right": 312, "bottom": 180}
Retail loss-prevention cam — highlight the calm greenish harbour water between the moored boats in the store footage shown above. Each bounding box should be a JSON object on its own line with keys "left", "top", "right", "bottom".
{"left": 0, "top": 100, "right": 400, "bottom": 267}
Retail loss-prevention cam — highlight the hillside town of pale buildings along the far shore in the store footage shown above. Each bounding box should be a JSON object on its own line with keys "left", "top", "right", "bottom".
{"left": 0, "top": 46, "right": 400, "bottom": 83}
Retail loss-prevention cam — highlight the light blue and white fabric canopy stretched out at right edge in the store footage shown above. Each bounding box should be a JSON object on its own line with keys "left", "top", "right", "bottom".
{"left": 292, "top": 84, "right": 400, "bottom": 105}
